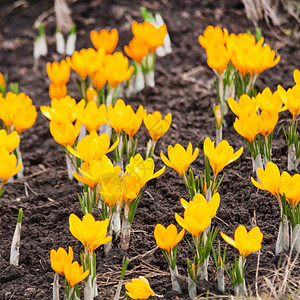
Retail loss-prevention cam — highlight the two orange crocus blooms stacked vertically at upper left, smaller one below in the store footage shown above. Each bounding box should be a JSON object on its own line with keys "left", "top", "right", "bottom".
{"left": 47, "top": 60, "right": 71, "bottom": 99}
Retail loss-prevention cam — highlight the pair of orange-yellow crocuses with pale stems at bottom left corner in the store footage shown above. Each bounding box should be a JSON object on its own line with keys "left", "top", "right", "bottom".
{"left": 50, "top": 247, "right": 89, "bottom": 300}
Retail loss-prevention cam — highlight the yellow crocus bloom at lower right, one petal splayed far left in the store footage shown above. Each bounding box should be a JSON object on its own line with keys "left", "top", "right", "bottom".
{"left": 221, "top": 225, "right": 263, "bottom": 258}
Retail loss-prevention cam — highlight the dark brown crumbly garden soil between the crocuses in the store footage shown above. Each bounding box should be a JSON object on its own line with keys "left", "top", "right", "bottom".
{"left": 0, "top": 0, "right": 300, "bottom": 300}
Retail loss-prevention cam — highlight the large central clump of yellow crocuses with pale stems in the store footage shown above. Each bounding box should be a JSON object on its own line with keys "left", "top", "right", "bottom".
{"left": 68, "top": 131, "right": 164, "bottom": 251}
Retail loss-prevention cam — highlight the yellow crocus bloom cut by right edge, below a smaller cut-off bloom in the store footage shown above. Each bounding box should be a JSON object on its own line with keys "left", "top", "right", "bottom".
{"left": 277, "top": 84, "right": 300, "bottom": 120}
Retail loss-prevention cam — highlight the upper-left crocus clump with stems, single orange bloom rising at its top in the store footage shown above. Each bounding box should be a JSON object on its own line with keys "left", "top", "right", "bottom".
{"left": 66, "top": 28, "right": 134, "bottom": 107}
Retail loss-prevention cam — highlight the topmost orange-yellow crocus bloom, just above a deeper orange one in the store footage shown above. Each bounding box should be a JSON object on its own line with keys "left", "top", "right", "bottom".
{"left": 131, "top": 21, "right": 167, "bottom": 53}
